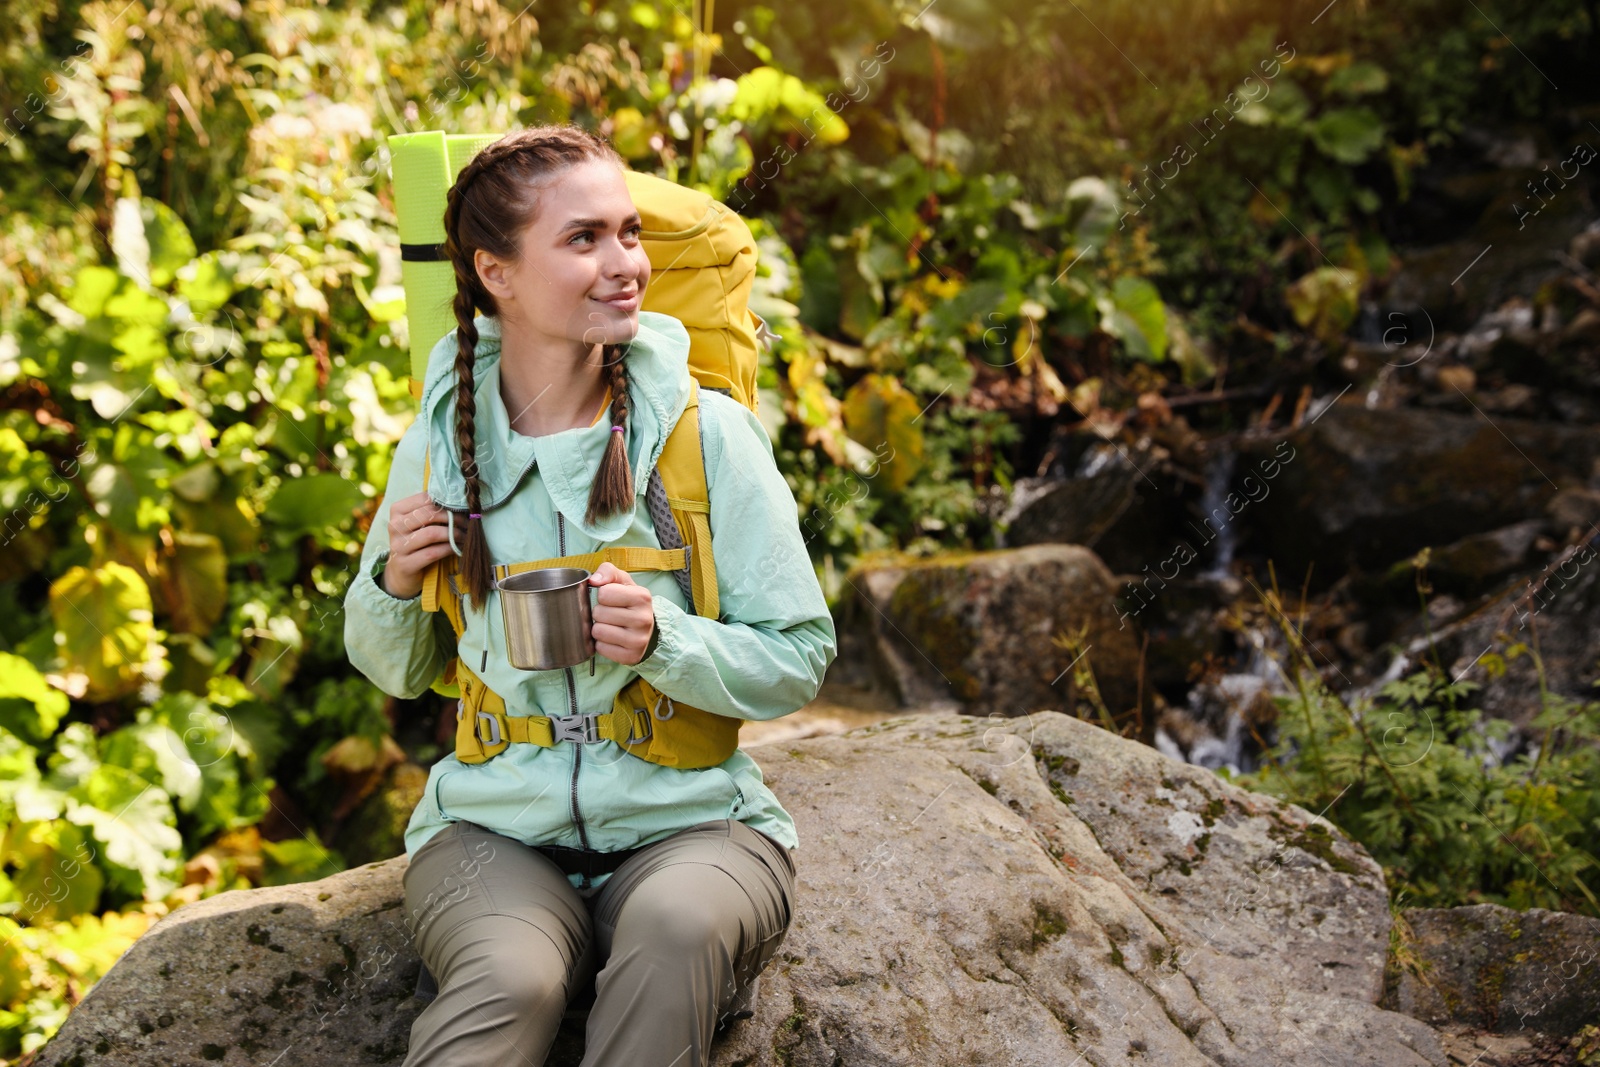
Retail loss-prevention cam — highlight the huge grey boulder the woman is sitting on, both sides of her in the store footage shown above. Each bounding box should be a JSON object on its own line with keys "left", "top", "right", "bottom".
{"left": 37, "top": 712, "right": 1445, "bottom": 1067}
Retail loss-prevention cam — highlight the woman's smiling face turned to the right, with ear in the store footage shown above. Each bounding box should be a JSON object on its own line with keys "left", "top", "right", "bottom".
{"left": 477, "top": 160, "right": 650, "bottom": 346}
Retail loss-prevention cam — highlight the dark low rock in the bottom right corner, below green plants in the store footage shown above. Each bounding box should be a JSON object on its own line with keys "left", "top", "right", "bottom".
{"left": 1384, "top": 904, "right": 1600, "bottom": 1037}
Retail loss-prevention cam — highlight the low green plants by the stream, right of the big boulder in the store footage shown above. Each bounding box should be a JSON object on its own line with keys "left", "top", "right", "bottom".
{"left": 1238, "top": 593, "right": 1600, "bottom": 917}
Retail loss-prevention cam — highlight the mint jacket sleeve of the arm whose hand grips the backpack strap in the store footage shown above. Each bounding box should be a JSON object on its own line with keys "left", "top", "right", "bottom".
{"left": 344, "top": 419, "right": 454, "bottom": 699}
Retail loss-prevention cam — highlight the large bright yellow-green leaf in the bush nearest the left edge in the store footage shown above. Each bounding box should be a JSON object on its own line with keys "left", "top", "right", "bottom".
{"left": 50, "top": 561, "right": 155, "bottom": 702}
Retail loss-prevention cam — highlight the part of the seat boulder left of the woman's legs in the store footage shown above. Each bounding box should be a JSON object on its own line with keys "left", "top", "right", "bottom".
{"left": 34, "top": 856, "right": 421, "bottom": 1067}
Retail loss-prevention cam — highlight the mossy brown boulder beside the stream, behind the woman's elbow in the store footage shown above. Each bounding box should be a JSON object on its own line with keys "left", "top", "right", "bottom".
{"left": 838, "top": 544, "right": 1155, "bottom": 741}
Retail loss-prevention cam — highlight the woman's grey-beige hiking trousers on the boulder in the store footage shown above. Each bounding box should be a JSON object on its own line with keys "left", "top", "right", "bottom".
{"left": 403, "top": 819, "right": 795, "bottom": 1067}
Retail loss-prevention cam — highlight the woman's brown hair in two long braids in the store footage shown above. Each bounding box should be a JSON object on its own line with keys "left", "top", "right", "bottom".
{"left": 445, "top": 123, "right": 634, "bottom": 609}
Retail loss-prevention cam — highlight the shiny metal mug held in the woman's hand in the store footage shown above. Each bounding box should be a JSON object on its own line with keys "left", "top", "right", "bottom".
{"left": 494, "top": 566, "right": 595, "bottom": 670}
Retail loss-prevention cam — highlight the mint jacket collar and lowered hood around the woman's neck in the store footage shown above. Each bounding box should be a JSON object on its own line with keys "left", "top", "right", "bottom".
{"left": 418, "top": 310, "right": 690, "bottom": 541}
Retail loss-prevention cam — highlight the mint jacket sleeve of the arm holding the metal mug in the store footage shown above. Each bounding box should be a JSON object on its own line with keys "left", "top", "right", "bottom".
{"left": 634, "top": 390, "right": 837, "bottom": 720}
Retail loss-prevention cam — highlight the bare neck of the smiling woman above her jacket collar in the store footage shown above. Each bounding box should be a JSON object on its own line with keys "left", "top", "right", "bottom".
{"left": 499, "top": 316, "right": 606, "bottom": 437}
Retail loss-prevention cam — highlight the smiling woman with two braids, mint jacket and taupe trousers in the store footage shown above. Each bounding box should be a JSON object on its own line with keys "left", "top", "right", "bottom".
{"left": 346, "top": 126, "right": 835, "bottom": 1067}
